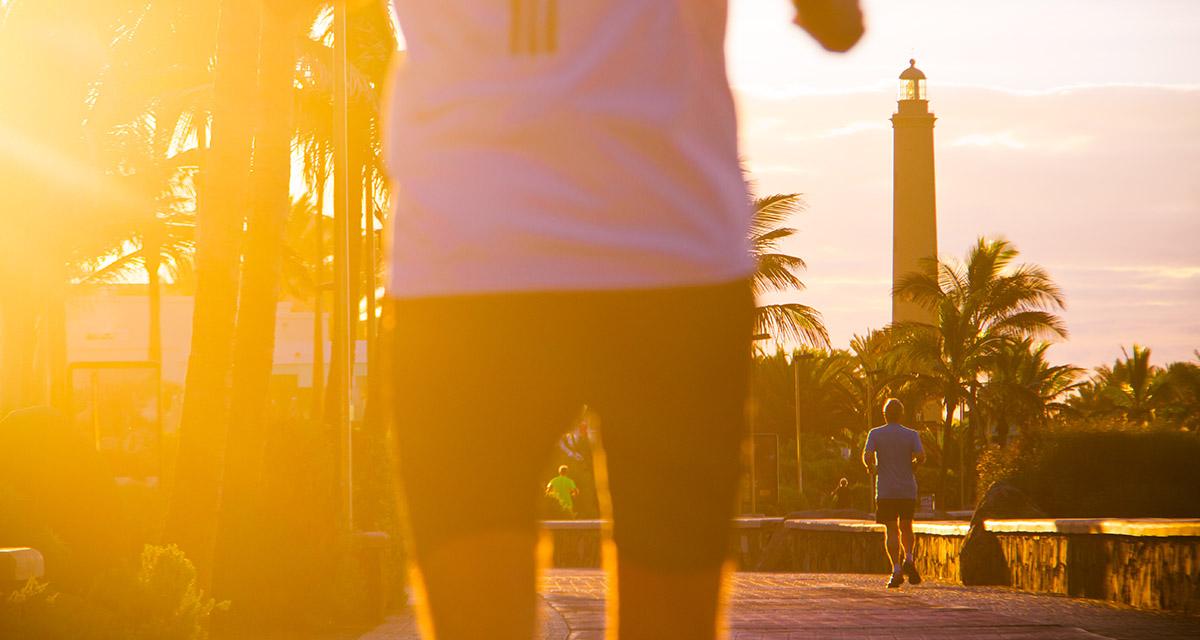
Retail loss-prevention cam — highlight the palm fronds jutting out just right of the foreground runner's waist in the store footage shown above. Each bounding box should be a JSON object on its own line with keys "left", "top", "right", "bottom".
{"left": 750, "top": 193, "right": 829, "bottom": 348}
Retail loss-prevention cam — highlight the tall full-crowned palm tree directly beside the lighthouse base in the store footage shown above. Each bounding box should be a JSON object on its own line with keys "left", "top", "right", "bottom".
{"left": 893, "top": 238, "right": 1067, "bottom": 501}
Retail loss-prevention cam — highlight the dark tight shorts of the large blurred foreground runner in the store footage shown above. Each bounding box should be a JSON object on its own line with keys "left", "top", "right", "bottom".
{"left": 389, "top": 281, "right": 754, "bottom": 569}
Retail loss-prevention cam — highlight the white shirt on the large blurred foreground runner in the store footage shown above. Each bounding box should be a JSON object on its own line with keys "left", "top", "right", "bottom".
{"left": 386, "top": 0, "right": 754, "bottom": 297}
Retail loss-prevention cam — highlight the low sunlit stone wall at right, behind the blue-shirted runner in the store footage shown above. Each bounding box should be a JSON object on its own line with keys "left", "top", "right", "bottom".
{"left": 766, "top": 519, "right": 1200, "bottom": 612}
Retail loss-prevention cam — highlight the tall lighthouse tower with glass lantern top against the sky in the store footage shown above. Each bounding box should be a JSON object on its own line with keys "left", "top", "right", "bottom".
{"left": 892, "top": 65, "right": 937, "bottom": 322}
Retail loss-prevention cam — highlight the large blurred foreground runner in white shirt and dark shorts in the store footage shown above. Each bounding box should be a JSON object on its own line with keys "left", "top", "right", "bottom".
{"left": 388, "top": 0, "right": 863, "bottom": 640}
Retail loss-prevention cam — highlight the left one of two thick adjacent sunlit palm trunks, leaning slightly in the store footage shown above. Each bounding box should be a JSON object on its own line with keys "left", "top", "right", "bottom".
{"left": 163, "top": 0, "right": 259, "bottom": 585}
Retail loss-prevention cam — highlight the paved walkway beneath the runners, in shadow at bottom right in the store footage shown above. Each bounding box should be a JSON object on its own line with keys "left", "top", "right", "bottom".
{"left": 360, "top": 569, "right": 1200, "bottom": 640}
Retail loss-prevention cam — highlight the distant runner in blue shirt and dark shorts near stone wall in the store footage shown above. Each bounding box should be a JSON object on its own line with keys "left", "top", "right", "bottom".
{"left": 863, "top": 397, "right": 925, "bottom": 588}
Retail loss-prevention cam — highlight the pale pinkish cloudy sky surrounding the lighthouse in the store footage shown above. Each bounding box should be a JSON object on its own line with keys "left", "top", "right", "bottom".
{"left": 727, "top": 0, "right": 1200, "bottom": 367}
